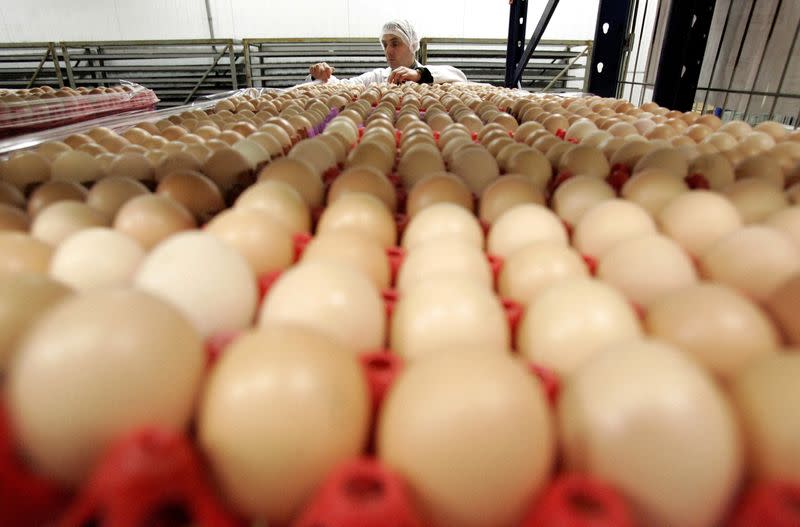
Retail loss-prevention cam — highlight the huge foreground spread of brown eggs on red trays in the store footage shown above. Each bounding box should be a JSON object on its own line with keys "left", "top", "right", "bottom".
{"left": 0, "top": 84, "right": 800, "bottom": 527}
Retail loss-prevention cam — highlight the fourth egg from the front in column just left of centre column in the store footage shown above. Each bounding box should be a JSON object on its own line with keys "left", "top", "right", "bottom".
{"left": 317, "top": 192, "right": 397, "bottom": 247}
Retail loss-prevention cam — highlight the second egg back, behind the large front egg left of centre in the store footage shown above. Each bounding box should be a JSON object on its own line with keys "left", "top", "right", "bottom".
{"left": 258, "top": 261, "right": 386, "bottom": 352}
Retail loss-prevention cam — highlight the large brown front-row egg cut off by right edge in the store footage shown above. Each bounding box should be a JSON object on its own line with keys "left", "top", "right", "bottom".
{"left": 731, "top": 352, "right": 800, "bottom": 481}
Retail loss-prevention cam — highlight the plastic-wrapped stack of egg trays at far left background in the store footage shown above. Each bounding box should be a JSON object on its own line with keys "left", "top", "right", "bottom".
{"left": 0, "top": 81, "right": 159, "bottom": 139}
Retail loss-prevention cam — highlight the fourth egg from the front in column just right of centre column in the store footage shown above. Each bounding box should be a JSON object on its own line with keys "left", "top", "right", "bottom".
{"left": 486, "top": 203, "right": 569, "bottom": 258}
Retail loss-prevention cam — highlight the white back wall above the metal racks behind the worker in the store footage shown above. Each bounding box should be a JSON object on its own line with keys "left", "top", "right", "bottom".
{"left": 0, "top": 0, "right": 598, "bottom": 42}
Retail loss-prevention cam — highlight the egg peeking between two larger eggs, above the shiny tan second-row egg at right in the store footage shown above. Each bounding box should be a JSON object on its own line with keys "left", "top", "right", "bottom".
{"left": 656, "top": 190, "right": 742, "bottom": 258}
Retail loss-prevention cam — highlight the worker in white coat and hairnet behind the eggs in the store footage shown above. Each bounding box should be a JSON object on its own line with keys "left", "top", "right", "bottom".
{"left": 307, "top": 20, "right": 467, "bottom": 85}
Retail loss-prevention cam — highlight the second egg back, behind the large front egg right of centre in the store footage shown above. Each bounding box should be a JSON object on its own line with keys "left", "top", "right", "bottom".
{"left": 517, "top": 275, "right": 642, "bottom": 376}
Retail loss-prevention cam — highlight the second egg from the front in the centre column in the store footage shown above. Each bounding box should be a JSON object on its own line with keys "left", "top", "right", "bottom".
{"left": 389, "top": 275, "right": 511, "bottom": 360}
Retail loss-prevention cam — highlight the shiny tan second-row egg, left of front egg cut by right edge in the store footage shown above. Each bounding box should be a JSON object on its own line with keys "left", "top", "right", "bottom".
{"left": 645, "top": 283, "right": 780, "bottom": 381}
